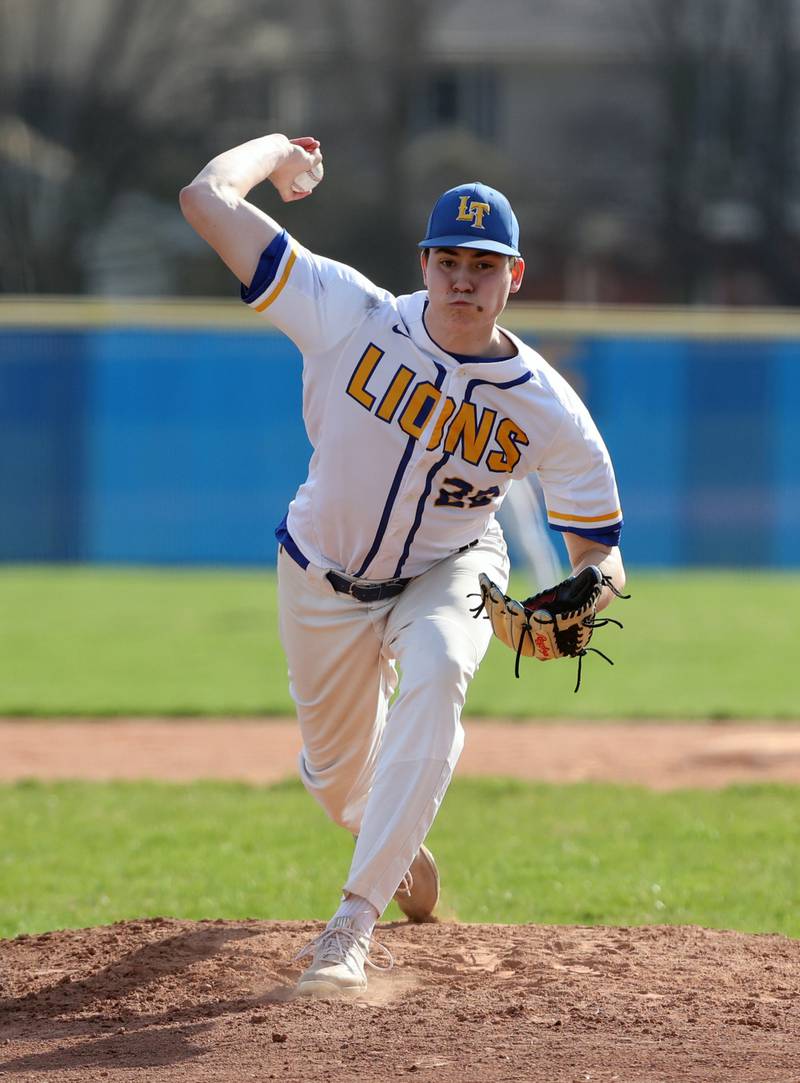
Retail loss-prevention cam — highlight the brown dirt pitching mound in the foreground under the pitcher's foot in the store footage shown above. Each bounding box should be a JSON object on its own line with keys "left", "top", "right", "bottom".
{"left": 0, "top": 918, "right": 800, "bottom": 1083}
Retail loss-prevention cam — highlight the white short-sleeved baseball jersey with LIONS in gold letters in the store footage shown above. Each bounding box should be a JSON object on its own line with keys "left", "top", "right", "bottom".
{"left": 241, "top": 232, "right": 622, "bottom": 580}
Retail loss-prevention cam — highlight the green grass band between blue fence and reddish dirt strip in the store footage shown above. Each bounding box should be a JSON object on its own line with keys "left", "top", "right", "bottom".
{"left": 0, "top": 566, "right": 800, "bottom": 719}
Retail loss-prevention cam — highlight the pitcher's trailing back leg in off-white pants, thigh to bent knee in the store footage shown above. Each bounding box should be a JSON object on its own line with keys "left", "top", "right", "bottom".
{"left": 278, "top": 552, "right": 396, "bottom": 834}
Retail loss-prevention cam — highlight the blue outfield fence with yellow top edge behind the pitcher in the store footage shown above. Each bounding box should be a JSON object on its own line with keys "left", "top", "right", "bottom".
{"left": 0, "top": 302, "right": 800, "bottom": 567}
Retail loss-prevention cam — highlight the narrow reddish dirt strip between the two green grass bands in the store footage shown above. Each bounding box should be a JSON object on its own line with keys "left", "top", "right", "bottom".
{"left": 0, "top": 719, "right": 800, "bottom": 790}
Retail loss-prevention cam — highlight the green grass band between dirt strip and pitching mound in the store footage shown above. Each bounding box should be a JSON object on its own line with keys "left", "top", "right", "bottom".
{"left": 0, "top": 780, "right": 800, "bottom": 936}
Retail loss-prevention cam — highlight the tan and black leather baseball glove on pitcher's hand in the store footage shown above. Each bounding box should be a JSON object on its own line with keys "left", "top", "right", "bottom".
{"left": 472, "top": 564, "right": 629, "bottom": 692}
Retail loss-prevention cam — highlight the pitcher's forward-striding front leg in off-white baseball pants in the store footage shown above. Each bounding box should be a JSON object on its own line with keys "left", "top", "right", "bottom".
{"left": 345, "top": 535, "right": 508, "bottom": 913}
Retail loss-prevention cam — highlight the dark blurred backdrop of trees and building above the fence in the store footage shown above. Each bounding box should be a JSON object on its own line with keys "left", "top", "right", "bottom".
{"left": 0, "top": 0, "right": 800, "bottom": 304}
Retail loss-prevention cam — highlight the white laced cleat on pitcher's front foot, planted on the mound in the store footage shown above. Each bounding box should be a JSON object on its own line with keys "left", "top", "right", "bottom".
{"left": 294, "top": 917, "right": 394, "bottom": 996}
